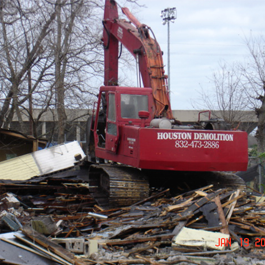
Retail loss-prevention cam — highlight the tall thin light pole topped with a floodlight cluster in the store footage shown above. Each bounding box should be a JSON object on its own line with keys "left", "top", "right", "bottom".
{"left": 161, "top": 7, "right": 177, "bottom": 101}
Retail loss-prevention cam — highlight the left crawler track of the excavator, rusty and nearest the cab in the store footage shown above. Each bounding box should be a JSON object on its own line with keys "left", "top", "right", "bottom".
{"left": 89, "top": 164, "right": 149, "bottom": 209}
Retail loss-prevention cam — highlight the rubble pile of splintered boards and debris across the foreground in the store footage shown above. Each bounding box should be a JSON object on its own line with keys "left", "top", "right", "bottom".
{"left": 0, "top": 178, "right": 265, "bottom": 265}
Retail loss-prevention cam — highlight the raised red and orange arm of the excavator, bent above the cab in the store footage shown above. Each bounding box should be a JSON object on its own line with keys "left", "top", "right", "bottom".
{"left": 103, "top": 0, "right": 173, "bottom": 119}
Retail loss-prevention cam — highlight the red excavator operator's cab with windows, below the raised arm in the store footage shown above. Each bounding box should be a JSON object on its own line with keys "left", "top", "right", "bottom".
{"left": 94, "top": 86, "right": 154, "bottom": 160}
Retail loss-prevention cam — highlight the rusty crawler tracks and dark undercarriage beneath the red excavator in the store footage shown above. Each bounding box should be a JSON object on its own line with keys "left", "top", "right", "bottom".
{"left": 89, "top": 164, "right": 246, "bottom": 209}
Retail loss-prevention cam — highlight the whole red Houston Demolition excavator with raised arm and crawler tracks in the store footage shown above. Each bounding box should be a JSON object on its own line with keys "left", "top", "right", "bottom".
{"left": 88, "top": 0, "right": 248, "bottom": 207}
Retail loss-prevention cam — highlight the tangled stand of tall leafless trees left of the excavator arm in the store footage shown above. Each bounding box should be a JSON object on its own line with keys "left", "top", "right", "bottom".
{"left": 0, "top": 0, "right": 140, "bottom": 142}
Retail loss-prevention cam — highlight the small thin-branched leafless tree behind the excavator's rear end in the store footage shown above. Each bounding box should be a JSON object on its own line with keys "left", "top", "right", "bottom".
{"left": 197, "top": 62, "right": 255, "bottom": 133}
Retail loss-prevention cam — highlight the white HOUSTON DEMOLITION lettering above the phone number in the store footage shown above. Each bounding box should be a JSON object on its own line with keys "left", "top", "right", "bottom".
{"left": 157, "top": 132, "right": 234, "bottom": 142}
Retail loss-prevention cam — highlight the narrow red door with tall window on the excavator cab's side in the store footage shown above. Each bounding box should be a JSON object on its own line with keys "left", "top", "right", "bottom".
{"left": 106, "top": 92, "right": 119, "bottom": 153}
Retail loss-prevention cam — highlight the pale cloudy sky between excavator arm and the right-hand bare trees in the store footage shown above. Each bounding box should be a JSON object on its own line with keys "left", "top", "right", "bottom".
{"left": 122, "top": 0, "right": 265, "bottom": 109}
